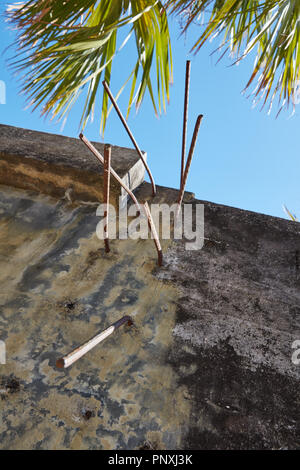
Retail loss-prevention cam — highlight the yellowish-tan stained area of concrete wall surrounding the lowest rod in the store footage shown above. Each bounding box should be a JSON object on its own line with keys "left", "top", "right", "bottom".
{"left": 0, "top": 190, "right": 189, "bottom": 449}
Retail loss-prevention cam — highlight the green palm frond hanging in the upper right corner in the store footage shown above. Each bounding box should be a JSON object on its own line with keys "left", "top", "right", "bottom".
{"left": 167, "top": 0, "right": 300, "bottom": 114}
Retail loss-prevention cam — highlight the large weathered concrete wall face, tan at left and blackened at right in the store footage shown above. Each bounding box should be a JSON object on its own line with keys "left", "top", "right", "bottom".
{"left": 0, "top": 184, "right": 300, "bottom": 449}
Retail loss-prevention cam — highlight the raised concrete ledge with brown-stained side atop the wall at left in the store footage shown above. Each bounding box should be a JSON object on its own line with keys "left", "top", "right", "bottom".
{"left": 0, "top": 124, "right": 147, "bottom": 204}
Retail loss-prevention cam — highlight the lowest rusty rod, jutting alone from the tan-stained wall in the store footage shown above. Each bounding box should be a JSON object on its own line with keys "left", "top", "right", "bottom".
{"left": 56, "top": 315, "right": 133, "bottom": 369}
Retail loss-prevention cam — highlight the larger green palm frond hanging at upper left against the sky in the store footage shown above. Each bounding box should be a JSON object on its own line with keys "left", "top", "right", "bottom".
{"left": 7, "top": 0, "right": 172, "bottom": 136}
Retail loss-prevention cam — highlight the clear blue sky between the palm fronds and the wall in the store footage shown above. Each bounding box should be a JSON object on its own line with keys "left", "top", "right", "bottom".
{"left": 0, "top": 1, "right": 300, "bottom": 218}
